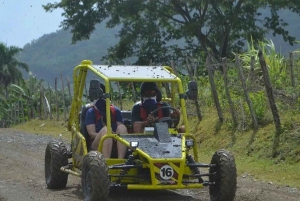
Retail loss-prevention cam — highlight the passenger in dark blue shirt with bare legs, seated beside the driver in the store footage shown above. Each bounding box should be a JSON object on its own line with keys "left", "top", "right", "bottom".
{"left": 85, "top": 82, "right": 128, "bottom": 158}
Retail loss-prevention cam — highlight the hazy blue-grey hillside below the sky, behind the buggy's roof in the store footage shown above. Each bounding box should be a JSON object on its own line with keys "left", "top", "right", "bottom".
{"left": 18, "top": 24, "right": 118, "bottom": 85}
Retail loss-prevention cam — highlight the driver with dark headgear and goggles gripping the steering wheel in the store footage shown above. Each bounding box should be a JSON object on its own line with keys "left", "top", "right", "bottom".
{"left": 131, "top": 82, "right": 183, "bottom": 133}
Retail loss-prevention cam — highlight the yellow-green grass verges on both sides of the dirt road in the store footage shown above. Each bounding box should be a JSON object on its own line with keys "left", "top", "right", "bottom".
{"left": 13, "top": 110, "right": 300, "bottom": 188}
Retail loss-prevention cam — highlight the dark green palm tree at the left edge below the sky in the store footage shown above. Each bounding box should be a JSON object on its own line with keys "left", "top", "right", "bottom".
{"left": 0, "top": 43, "right": 28, "bottom": 99}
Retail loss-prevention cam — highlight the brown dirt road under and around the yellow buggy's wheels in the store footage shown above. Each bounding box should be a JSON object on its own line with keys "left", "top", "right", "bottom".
{"left": 0, "top": 129, "right": 300, "bottom": 201}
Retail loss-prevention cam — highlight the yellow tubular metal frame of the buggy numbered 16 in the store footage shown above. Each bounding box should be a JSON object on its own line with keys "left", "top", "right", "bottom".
{"left": 66, "top": 60, "right": 203, "bottom": 190}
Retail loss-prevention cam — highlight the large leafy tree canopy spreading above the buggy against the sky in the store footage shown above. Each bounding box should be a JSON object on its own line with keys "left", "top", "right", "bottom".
{"left": 44, "top": 0, "right": 300, "bottom": 64}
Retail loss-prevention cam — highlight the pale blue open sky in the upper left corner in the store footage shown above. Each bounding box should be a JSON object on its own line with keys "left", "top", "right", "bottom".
{"left": 0, "top": 0, "right": 63, "bottom": 48}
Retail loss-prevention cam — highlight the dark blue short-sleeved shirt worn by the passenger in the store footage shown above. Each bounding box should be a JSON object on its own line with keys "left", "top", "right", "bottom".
{"left": 85, "top": 101, "right": 123, "bottom": 132}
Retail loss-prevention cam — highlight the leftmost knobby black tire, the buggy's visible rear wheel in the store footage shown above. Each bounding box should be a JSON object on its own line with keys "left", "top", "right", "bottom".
{"left": 45, "top": 141, "right": 68, "bottom": 189}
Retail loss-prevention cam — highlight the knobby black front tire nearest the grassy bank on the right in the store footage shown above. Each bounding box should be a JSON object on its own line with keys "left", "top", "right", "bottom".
{"left": 209, "top": 149, "right": 237, "bottom": 201}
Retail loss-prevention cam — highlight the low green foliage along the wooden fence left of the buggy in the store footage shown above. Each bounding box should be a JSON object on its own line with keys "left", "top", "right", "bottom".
{"left": 0, "top": 72, "right": 71, "bottom": 126}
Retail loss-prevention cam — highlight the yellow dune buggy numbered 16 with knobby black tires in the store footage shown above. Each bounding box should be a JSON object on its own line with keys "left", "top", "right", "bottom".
{"left": 45, "top": 60, "right": 237, "bottom": 201}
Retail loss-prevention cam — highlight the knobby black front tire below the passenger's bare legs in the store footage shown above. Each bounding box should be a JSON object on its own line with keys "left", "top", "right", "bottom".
{"left": 81, "top": 151, "right": 110, "bottom": 201}
